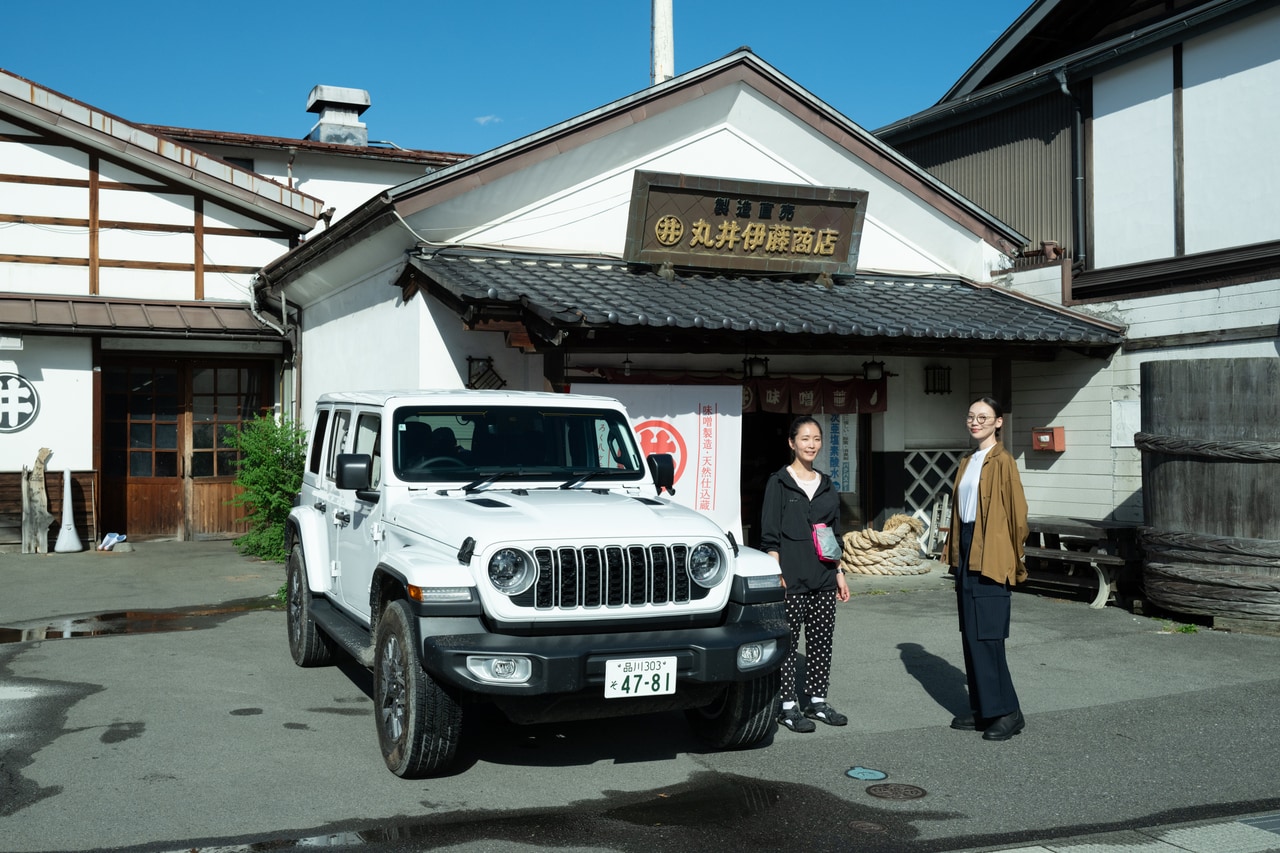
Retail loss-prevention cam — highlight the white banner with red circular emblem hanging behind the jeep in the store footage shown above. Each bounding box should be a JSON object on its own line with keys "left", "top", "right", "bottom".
{"left": 572, "top": 386, "right": 742, "bottom": 542}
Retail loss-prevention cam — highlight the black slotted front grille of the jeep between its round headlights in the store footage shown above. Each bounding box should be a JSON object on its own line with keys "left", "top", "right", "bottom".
{"left": 513, "top": 544, "right": 708, "bottom": 610}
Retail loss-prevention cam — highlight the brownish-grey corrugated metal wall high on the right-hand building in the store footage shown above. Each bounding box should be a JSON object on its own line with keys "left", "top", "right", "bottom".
{"left": 884, "top": 92, "right": 1074, "bottom": 252}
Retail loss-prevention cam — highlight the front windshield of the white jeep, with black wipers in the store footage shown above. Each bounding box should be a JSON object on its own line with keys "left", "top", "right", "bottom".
{"left": 392, "top": 406, "right": 644, "bottom": 487}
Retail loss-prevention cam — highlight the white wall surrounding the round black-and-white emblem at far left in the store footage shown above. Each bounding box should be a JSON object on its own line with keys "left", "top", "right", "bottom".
{"left": 0, "top": 334, "right": 93, "bottom": 471}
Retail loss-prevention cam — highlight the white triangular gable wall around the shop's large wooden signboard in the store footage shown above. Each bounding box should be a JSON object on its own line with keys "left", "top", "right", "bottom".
{"left": 410, "top": 86, "right": 996, "bottom": 280}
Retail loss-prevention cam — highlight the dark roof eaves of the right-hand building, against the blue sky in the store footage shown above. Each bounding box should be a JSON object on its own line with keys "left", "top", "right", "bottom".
{"left": 876, "top": 0, "right": 1274, "bottom": 137}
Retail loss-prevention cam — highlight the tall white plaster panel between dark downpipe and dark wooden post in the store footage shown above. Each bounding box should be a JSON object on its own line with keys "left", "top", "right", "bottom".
{"left": 1091, "top": 50, "right": 1174, "bottom": 266}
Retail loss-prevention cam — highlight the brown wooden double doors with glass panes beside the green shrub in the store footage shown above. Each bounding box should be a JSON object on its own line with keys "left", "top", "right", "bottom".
{"left": 101, "top": 359, "right": 270, "bottom": 539}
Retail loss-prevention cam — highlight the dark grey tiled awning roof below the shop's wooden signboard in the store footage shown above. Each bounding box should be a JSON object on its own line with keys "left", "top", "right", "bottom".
{"left": 413, "top": 250, "right": 1124, "bottom": 347}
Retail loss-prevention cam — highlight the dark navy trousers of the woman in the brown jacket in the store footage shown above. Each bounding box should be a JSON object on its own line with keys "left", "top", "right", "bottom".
{"left": 956, "top": 524, "right": 1019, "bottom": 719}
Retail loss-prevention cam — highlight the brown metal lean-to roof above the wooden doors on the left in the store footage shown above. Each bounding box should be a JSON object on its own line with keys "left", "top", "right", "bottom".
{"left": 0, "top": 293, "right": 280, "bottom": 338}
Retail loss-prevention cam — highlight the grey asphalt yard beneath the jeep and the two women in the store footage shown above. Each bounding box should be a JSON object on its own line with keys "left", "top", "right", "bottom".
{"left": 0, "top": 543, "right": 1280, "bottom": 853}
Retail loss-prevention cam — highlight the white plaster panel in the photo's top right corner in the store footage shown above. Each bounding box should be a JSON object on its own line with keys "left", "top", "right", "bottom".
{"left": 1183, "top": 9, "right": 1280, "bottom": 254}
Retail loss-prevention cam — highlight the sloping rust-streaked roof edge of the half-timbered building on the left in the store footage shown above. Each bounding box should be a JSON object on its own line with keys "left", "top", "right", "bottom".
{"left": 0, "top": 69, "right": 323, "bottom": 232}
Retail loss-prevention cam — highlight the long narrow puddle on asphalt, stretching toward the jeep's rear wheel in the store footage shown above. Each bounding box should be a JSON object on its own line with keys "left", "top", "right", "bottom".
{"left": 0, "top": 598, "right": 282, "bottom": 643}
